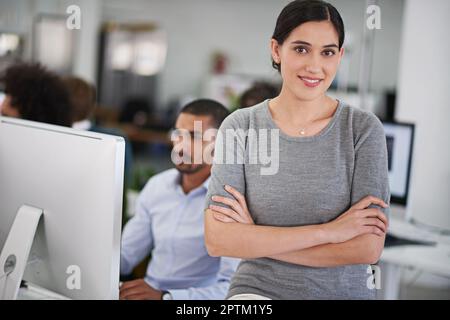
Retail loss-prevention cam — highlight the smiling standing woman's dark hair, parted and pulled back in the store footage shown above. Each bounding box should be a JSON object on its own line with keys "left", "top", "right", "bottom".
{"left": 272, "top": 0, "right": 345, "bottom": 72}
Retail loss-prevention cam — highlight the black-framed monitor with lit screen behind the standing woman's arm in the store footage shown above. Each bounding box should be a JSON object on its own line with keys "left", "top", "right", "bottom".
{"left": 383, "top": 121, "right": 414, "bottom": 205}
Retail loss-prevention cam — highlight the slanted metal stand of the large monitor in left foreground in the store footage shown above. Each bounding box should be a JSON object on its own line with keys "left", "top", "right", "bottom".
{"left": 0, "top": 205, "right": 43, "bottom": 300}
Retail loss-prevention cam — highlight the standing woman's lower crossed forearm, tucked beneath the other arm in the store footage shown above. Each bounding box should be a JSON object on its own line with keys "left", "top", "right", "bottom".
{"left": 269, "top": 234, "right": 384, "bottom": 267}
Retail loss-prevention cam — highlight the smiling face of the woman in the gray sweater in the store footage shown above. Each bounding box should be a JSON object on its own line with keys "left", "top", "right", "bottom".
{"left": 271, "top": 21, "right": 344, "bottom": 101}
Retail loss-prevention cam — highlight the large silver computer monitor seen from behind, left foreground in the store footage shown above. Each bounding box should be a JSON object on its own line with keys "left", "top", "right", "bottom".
{"left": 0, "top": 117, "right": 125, "bottom": 299}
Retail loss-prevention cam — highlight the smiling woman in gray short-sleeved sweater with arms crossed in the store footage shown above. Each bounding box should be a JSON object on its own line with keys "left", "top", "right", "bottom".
{"left": 205, "top": 0, "right": 390, "bottom": 299}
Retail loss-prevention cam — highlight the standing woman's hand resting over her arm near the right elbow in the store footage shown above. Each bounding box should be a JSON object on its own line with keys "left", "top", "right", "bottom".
{"left": 323, "top": 196, "right": 388, "bottom": 243}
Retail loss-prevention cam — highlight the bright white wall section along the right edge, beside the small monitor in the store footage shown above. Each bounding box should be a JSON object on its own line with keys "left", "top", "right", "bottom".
{"left": 396, "top": 0, "right": 450, "bottom": 230}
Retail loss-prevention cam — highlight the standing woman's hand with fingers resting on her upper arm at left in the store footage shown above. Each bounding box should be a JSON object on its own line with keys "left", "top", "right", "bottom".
{"left": 209, "top": 185, "right": 255, "bottom": 224}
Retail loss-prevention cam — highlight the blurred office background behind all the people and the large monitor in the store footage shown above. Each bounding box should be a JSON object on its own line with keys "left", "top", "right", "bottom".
{"left": 0, "top": 0, "right": 450, "bottom": 299}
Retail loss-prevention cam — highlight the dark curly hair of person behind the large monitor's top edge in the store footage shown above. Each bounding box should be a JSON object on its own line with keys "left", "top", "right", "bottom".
{"left": 1, "top": 63, "right": 72, "bottom": 127}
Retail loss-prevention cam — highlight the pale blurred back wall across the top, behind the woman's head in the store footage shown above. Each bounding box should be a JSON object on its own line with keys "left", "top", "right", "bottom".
{"left": 0, "top": 0, "right": 404, "bottom": 105}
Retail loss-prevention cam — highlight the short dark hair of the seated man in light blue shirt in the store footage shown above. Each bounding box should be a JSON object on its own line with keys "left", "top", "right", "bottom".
{"left": 180, "top": 99, "right": 230, "bottom": 128}
